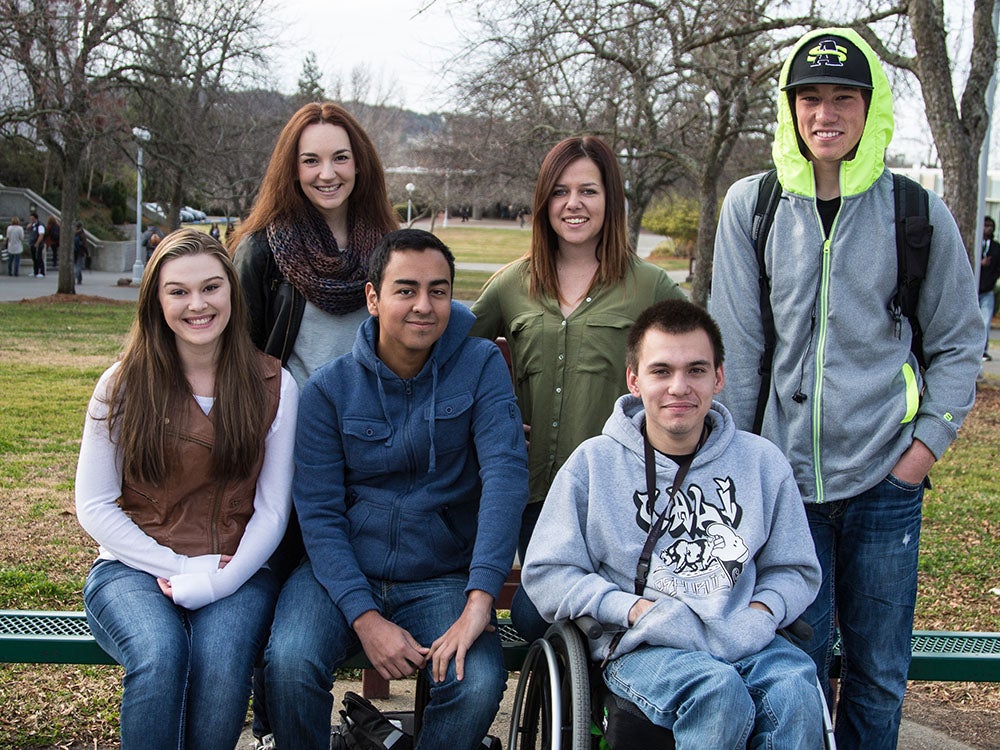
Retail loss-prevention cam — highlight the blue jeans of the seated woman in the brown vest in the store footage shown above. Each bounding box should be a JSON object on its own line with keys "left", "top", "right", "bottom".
{"left": 83, "top": 560, "right": 278, "bottom": 750}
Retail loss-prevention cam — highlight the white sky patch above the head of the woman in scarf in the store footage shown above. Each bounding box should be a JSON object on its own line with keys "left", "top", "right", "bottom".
{"left": 269, "top": 0, "right": 469, "bottom": 113}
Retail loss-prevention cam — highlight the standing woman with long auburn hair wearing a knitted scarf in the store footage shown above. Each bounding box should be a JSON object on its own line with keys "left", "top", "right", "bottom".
{"left": 231, "top": 102, "right": 399, "bottom": 387}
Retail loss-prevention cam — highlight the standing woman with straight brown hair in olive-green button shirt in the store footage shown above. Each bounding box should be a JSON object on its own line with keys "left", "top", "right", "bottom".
{"left": 472, "top": 136, "right": 683, "bottom": 640}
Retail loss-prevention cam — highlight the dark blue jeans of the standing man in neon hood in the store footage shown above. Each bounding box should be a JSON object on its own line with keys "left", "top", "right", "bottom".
{"left": 801, "top": 475, "right": 924, "bottom": 750}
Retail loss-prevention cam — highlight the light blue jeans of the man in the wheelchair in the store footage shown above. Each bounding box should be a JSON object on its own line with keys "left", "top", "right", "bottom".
{"left": 604, "top": 637, "right": 823, "bottom": 750}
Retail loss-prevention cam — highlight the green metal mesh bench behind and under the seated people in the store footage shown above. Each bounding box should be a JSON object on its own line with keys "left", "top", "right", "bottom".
{"left": 0, "top": 610, "right": 1000, "bottom": 682}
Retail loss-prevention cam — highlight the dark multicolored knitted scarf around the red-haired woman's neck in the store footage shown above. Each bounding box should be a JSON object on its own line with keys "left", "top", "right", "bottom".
{"left": 267, "top": 210, "right": 382, "bottom": 315}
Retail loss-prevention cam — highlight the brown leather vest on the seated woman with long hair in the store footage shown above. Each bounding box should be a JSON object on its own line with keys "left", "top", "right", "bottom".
{"left": 118, "top": 354, "right": 282, "bottom": 556}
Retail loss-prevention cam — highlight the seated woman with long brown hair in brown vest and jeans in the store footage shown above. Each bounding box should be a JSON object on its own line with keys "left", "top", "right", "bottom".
{"left": 76, "top": 229, "right": 298, "bottom": 750}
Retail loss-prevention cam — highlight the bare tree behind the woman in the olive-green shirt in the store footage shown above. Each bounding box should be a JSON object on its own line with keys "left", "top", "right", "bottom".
{"left": 465, "top": 0, "right": 774, "bottom": 301}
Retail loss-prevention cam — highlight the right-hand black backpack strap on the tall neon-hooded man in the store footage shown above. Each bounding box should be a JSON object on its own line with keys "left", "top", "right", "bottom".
{"left": 889, "top": 173, "right": 934, "bottom": 370}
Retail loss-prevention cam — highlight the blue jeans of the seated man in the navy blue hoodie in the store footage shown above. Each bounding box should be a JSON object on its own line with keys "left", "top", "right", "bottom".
{"left": 264, "top": 561, "right": 507, "bottom": 750}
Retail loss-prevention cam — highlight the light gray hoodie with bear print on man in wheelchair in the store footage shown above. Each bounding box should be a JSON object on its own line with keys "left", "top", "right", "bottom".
{"left": 521, "top": 395, "right": 820, "bottom": 661}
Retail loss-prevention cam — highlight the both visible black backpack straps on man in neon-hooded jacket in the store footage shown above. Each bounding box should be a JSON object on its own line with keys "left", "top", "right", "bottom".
{"left": 750, "top": 169, "right": 934, "bottom": 435}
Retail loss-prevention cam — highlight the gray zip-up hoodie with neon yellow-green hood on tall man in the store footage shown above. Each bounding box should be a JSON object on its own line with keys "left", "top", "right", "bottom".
{"left": 710, "top": 29, "right": 983, "bottom": 502}
